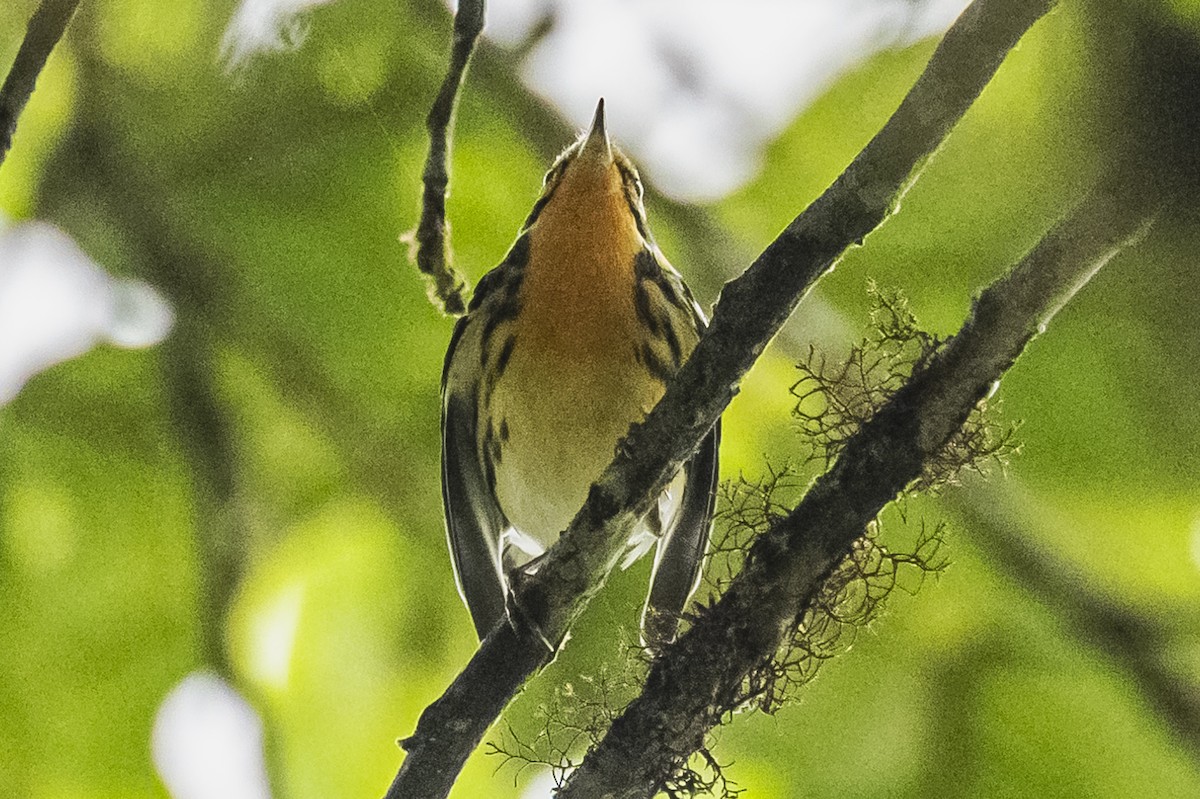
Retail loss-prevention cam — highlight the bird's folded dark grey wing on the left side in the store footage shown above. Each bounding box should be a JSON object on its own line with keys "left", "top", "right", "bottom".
{"left": 442, "top": 318, "right": 506, "bottom": 639}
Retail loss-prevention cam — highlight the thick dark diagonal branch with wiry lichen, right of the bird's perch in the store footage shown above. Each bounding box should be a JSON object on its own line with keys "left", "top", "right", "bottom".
{"left": 558, "top": 184, "right": 1145, "bottom": 799}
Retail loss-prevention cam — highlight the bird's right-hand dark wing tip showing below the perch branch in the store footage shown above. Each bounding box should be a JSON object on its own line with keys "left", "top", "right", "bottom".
{"left": 642, "top": 412, "right": 721, "bottom": 648}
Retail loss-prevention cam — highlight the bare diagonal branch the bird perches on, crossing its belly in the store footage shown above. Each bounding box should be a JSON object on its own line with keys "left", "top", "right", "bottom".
{"left": 386, "top": 0, "right": 1054, "bottom": 799}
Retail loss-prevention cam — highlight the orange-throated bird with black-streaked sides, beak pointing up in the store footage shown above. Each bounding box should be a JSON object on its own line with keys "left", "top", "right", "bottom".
{"left": 442, "top": 98, "right": 720, "bottom": 650}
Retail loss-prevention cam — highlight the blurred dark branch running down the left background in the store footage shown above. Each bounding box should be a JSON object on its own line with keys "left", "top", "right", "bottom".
{"left": 35, "top": 36, "right": 292, "bottom": 797}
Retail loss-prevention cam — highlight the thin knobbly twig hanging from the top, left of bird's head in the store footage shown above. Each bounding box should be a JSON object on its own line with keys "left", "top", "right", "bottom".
{"left": 413, "top": 0, "right": 485, "bottom": 316}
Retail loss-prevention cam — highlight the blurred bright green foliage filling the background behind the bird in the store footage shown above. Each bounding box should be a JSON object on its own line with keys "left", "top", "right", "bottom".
{"left": 0, "top": 0, "right": 1200, "bottom": 799}
